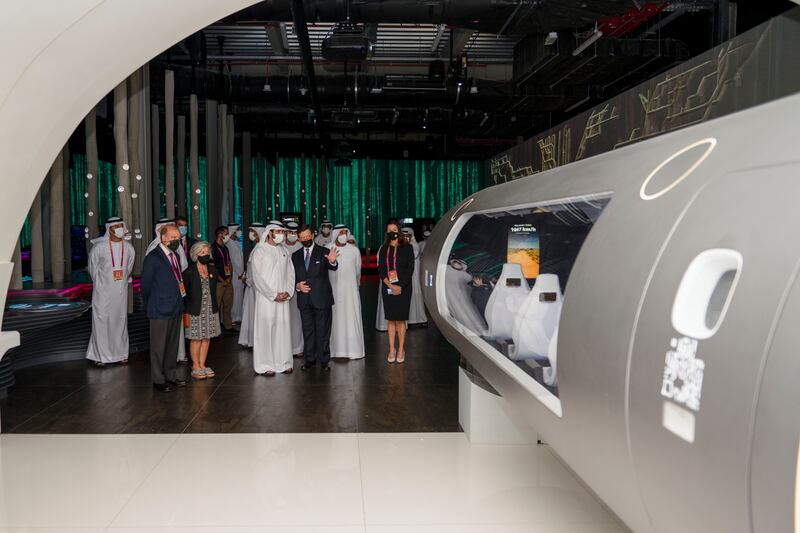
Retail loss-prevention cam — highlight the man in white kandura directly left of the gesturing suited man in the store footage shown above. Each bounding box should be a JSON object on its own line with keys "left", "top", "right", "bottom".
{"left": 247, "top": 221, "right": 294, "bottom": 376}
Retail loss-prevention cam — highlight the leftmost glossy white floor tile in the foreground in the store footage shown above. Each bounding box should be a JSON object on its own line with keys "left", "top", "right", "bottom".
{"left": 0, "top": 435, "right": 177, "bottom": 531}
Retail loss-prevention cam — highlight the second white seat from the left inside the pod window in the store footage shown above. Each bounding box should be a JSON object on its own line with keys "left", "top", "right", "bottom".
{"left": 509, "top": 274, "right": 562, "bottom": 363}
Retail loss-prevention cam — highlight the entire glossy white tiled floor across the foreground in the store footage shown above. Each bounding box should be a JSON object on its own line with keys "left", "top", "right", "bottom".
{"left": 0, "top": 433, "right": 627, "bottom": 533}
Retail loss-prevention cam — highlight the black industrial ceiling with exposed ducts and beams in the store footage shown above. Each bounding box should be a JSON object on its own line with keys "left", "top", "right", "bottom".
{"left": 141, "top": 0, "right": 792, "bottom": 159}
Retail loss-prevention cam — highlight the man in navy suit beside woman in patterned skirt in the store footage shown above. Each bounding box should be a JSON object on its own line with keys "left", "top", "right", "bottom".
{"left": 142, "top": 224, "right": 186, "bottom": 392}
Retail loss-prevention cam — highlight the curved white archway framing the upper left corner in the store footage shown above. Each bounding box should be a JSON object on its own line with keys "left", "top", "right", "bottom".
{"left": 0, "top": 0, "right": 258, "bottom": 358}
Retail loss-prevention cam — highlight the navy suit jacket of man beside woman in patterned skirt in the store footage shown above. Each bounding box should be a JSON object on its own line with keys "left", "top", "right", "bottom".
{"left": 142, "top": 245, "right": 183, "bottom": 320}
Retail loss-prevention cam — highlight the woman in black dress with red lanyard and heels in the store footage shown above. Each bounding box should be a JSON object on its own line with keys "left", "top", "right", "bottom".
{"left": 378, "top": 222, "right": 414, "bottom": 363}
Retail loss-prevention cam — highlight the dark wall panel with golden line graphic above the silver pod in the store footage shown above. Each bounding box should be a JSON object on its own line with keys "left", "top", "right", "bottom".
{"left": 487, "top": 8, "right": 800, "bottom": 185}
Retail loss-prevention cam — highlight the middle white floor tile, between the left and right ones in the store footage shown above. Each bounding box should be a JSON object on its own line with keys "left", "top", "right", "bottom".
{"left": 111, "top": 434, "right": 363, "bottom": 527}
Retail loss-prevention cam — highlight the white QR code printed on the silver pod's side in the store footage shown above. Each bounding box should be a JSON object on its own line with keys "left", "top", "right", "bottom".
{"left": 661, "top": 337, "right": 706, "bottom": 411}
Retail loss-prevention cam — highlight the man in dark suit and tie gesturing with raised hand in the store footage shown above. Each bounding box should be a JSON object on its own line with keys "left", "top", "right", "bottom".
{"left": 292, "top": 224, "right": 339, "bottom": 371}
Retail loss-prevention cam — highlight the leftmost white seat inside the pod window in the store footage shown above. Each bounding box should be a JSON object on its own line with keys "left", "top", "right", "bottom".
{"left": 484, "top": 263, "right": 531, "bottom": 340}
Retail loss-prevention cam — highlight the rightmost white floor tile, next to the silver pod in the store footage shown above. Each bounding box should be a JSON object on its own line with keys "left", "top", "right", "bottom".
{"left": 359, "top": 433, "right": 624, "bottom": 531}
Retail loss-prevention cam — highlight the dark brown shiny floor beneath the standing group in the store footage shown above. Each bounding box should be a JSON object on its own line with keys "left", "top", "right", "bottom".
{"left": 0, "top": 279, "right": 459, "bottom": 433}
